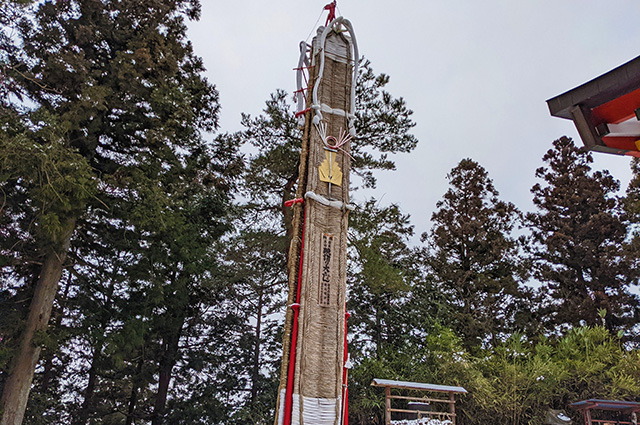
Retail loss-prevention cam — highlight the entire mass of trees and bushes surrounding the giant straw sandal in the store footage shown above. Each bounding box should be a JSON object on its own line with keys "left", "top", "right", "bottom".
{"left": 0, "top": 0, "right": 640, "bottom": 425}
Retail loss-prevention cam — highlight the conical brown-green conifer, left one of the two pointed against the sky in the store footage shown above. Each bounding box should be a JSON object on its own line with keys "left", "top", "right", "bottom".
{"left": 422, "top": 159, "right": 524, "bottom": 352}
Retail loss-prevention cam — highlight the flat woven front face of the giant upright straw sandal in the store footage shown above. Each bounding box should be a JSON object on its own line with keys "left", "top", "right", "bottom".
{"left": 293, "top": 28, "right": 353, "bottom": 424}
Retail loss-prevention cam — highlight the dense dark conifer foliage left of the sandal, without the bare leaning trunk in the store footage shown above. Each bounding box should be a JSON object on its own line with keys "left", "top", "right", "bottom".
{"left": 0, "top": 0, "right": 242, "bottom": 424}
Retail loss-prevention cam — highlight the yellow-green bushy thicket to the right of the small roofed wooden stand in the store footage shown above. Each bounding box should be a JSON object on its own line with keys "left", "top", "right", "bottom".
{"left": 462, "top": 326, "right": 640, "bottom": 425}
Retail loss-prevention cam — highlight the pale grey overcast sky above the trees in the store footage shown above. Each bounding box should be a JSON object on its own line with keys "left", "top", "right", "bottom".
{"left": 189, "top": 0, "right": 640, "bottom": 234}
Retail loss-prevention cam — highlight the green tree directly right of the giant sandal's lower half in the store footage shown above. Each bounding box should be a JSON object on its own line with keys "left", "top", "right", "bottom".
{"left": 347, "top": 199, "right": 424, "bottom": 423}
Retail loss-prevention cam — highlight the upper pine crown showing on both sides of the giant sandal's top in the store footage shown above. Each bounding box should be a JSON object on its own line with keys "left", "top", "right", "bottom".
{"left": 236, "top": 60, "right": 418, "bottom": 234}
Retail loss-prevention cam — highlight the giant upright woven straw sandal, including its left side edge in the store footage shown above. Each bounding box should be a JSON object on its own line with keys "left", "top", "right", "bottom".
{"left": 276, "top": 19, "right": 357, "bottom": 425}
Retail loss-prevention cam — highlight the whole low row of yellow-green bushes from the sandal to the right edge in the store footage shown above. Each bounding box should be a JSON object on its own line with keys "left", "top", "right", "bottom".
{"left": 349, "top": 326, "right": 640, "bottom": 425}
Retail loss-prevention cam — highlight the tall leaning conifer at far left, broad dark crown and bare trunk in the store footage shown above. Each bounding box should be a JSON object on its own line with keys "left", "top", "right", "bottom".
{"left": 1, "top": 0, "right": 225, "bottom": 424}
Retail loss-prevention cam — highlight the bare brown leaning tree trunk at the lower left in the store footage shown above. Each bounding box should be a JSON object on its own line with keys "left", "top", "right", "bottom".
{"left": 0, "top": 217, "right": 76, "bottom": 425}
